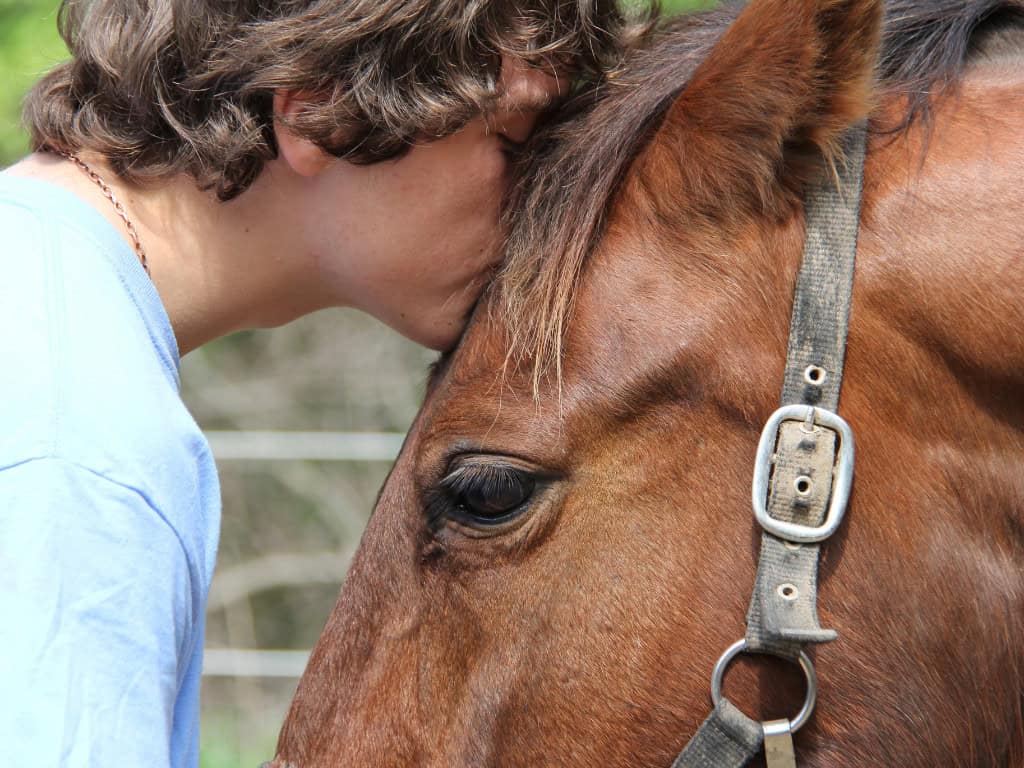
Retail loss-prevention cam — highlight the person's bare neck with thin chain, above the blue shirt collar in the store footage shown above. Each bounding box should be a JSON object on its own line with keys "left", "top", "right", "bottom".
{"left": 7, "top": 154, "right": 343, "bottom": 355}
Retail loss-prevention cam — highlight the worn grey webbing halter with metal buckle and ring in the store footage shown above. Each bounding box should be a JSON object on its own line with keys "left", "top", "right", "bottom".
{"left": 672, "top": 124, "right": 867, "bottom": 768}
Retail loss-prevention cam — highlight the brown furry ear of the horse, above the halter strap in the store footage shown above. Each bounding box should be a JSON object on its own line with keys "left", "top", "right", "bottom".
{"left": 655, "top": 0, "right": 882, "bottom": 221}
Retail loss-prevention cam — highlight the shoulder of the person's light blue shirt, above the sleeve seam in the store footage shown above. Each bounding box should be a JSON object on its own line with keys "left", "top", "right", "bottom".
{"left": 0, "top": 179, "right": 216, "bottom": 548}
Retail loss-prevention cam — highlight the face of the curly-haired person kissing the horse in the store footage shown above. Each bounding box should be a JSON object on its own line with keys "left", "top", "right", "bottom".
{"left": 304, "top": 59, "right": 566, "bottom": 349}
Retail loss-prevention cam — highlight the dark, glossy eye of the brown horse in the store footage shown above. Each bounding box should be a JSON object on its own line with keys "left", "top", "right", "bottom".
{"left": 444, "top": 465, "right": 537, "bottom": 524}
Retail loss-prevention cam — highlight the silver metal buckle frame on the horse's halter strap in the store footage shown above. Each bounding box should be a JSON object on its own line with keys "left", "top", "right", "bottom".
{"left": 751, "top": 406, "right": 853, "bottom": 544}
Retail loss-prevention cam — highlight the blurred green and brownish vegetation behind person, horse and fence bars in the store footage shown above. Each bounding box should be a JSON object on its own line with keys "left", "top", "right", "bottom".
{"left": 0, "top": 0, "right": 714, "bottom": 768}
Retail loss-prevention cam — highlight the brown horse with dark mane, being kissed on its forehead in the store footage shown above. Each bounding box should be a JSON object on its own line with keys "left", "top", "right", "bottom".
{"left": 273, "top": 0, "right": 1024, "bottom": 768}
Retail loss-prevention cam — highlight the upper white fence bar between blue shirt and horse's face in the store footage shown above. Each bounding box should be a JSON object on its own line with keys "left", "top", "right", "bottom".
{"left": 206, "top": 430, "right": 406, "bottom": 462}
